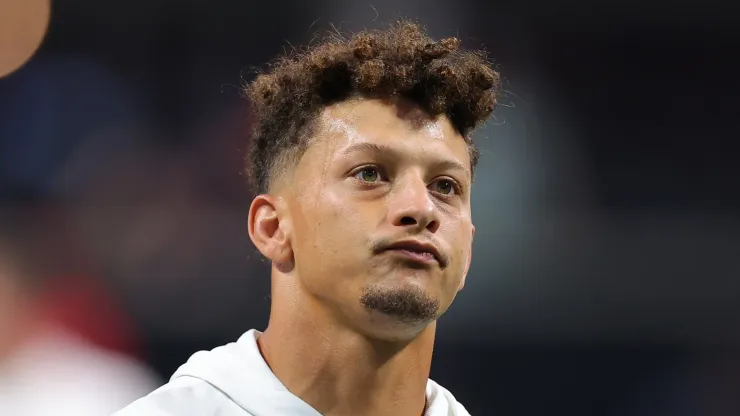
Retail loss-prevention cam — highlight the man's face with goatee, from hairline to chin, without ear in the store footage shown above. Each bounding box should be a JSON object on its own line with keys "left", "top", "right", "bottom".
{"left": 285, "top": 99, "right": 474, "bottom": 338}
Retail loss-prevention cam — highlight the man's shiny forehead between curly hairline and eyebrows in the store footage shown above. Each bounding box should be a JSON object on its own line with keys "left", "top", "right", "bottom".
{"left": 315, "top": 99, "right": 470, "bottom": 172}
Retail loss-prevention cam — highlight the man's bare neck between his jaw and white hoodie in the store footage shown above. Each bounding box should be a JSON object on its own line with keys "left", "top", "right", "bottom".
{"left": 258, "top": 274, "right": 436, "bottom": 416}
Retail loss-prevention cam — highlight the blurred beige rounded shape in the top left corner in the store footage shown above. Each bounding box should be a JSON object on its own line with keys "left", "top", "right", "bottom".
{"left": 0, "top": 0, "right": 51, "bottom": 78}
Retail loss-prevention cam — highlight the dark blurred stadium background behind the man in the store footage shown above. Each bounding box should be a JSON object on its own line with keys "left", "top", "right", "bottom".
{"left": 0, "top": 0, "right": 740, "bottom": 416}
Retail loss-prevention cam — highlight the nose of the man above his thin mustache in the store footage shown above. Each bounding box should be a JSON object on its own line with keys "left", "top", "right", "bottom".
{"left": 388, "top": 177, "right": 439, "bottom": 233}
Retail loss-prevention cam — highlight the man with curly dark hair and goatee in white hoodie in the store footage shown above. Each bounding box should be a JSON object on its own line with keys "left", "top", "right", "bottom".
{"left": 118, "top": 22, "right": 499, "bottom": 416}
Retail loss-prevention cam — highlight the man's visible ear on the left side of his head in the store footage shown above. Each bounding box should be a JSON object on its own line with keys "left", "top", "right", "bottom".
{"left": 249, "top": 195, "right": 293, "bottom": 266}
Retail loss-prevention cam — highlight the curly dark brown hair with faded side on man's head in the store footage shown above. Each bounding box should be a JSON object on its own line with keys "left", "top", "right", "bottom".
{"left": 244, "top": 20, "right": 500, "bottom": 193}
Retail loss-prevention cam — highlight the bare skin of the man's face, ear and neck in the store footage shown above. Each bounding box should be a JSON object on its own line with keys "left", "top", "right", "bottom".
{"left": 249, "top": 99, "right": 475, "bottom": 416}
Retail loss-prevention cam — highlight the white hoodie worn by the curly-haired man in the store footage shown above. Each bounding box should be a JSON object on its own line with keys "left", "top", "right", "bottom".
{"left": 113, "top": 329, "right": 470, "bottom": 416}
